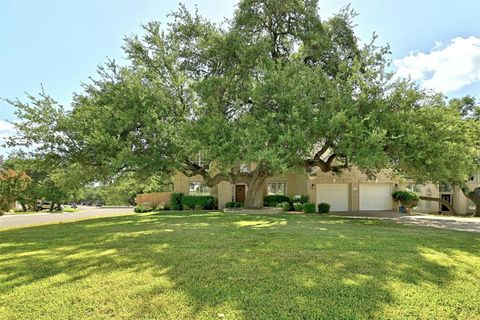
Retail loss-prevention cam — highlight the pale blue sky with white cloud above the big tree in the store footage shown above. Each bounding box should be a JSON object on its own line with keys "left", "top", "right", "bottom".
{"left": 0, "top": 0, "right": 480, "bottom": 154}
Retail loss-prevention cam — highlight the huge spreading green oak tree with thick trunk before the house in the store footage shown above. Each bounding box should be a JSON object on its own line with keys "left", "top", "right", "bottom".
{"left": 7, "top": 0, "right": 479, "bottom": 212}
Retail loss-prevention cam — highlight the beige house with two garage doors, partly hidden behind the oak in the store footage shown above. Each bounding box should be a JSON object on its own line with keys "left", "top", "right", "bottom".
{"left": 173, "top": 166, "right": 480, "bottom": 213}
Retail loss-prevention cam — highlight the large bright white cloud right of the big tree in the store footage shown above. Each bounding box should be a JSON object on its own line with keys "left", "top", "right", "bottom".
{"left": 393, "top": 36, "right": 480, "bottom": 93}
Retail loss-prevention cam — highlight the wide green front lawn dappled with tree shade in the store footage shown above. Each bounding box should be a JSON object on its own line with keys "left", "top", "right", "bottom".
{"left": 0, "top": 212, "right": 480, "bottom": 320}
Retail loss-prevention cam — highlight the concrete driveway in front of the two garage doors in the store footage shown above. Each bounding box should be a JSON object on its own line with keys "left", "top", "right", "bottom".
{"left": 332, "top": 211, "right": 480, "bottom": 232}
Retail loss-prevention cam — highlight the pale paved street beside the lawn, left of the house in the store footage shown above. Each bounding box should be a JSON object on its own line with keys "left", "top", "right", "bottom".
{"left": 0, "top": 207, "right": 133, "bottom": 229}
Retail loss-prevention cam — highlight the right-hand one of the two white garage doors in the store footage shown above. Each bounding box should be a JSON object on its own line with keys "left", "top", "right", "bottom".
{"left": 360, "top": 183, "right": 392, "bottom": 210}
